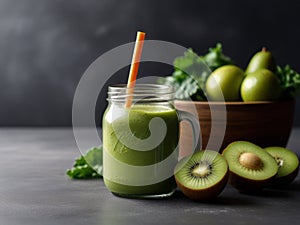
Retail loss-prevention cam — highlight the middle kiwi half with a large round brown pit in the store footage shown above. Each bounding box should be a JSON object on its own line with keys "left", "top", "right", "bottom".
{"left": 222, "top": 141, "right": 278, "bottom": 193}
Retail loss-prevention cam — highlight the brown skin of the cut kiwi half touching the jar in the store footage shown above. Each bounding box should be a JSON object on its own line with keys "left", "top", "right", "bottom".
{"left": 175, "top": 166, "right": 229, "bottom": 201}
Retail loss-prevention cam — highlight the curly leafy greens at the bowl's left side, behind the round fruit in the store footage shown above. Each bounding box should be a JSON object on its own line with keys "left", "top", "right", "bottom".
{"left": 158, "top": 43, "right": 233, "bottom": 101}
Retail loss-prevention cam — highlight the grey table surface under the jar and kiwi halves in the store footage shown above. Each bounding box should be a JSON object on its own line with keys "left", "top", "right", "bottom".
{"left": 0, "top": 128, "right": 300, "bottom": 225}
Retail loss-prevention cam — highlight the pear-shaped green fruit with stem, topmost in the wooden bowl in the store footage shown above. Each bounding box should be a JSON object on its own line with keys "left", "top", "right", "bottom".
{"left": 245, "top": 47, "right": 276, "bottom": 74}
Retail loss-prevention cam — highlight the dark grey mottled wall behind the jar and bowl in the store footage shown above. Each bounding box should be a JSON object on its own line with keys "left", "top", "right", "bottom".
{"left": 0, "top": 0, "right": 300, "bottom": 126}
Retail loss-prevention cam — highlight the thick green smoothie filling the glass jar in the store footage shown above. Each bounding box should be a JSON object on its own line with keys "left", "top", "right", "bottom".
{"left": 102, "top": 104, "right": 179, "bottom": 197}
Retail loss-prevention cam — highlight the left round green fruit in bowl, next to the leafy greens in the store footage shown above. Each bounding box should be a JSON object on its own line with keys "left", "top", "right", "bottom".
{"left": 205, "top": 65, "right": 244, "bottom": 101}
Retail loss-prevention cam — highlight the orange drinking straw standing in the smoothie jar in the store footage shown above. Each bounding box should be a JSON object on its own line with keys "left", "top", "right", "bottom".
{"left": 125, "top": 31, "right": 146, "bottom": 108}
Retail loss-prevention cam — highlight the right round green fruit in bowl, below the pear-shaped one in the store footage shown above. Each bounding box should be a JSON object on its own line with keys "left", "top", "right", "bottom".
{"left": 241, "top": 69, "right": 281, "bottom": 102}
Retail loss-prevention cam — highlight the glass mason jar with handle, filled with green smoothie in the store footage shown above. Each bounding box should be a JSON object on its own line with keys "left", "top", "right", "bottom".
{"left": 102, "top": 84, "right": 200, "bottom": 198}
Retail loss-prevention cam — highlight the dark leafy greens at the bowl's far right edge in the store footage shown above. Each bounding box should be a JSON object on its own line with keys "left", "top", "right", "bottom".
{"left": 276, "top": 65, "right": 300, "bottom": 98}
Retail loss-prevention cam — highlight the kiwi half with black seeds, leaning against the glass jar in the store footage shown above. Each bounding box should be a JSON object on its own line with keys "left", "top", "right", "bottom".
{"left": 174, "top": 150, "right": 229, "bottom": 200}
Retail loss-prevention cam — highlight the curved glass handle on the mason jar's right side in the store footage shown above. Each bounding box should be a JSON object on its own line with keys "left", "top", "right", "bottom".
{"left": 177, "top": 110, "right": 202, "bottom": 156}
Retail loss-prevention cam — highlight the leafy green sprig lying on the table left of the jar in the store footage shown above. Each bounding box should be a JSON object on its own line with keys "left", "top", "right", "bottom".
{"left": 66, "top": 146, "right": 103, "bottom": 179}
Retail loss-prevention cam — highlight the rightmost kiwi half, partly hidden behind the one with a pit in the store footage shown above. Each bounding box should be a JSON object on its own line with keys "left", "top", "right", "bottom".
{"left": 265, "top": 147, "right": 299, "bottom": 186}
